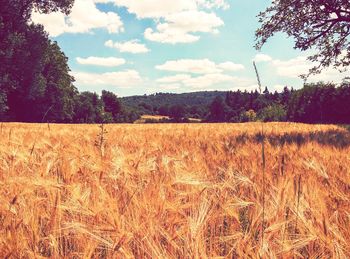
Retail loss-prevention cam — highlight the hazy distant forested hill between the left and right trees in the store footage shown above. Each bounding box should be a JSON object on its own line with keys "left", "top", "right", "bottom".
{"left": 120, "top": 91, "right": 227, "bottom": 118}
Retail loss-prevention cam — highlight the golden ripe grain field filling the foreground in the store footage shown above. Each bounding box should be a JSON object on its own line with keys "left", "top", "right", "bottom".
{"left": 0, "top": 123, "right": 350, "bottom": 258}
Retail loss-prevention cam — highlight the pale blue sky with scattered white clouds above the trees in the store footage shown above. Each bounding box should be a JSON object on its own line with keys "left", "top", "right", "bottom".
{"left": 32, "top": 0, "right": 350, "bottom": 96}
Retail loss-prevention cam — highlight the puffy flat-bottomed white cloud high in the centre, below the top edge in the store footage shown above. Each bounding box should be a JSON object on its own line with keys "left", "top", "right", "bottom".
{"left": 144, "top": 10, "right": 224, "bottom": 44}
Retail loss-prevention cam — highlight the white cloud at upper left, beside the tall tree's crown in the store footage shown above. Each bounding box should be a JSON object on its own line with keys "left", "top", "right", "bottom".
{"left": 32, "top": 0, "right": 124, "bottom": 37}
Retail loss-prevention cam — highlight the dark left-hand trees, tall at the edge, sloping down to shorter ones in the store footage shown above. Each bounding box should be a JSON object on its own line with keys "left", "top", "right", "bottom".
{"left": 0, "top": 0, "right": 138, "bottom": 123}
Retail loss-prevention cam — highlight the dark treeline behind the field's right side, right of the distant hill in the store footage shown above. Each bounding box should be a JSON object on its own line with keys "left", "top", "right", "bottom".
{"left": 206, "top": 83, "right": 350, "bottom": 124}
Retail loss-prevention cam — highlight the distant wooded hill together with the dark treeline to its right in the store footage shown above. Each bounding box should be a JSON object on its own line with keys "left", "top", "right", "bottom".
{"left": 122, "top": 80, "right": 350, "bottom": 124}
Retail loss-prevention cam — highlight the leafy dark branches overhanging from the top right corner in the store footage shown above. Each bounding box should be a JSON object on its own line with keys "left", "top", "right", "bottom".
{"left": 256, "top": 0, "right": 350, "bottom": 77}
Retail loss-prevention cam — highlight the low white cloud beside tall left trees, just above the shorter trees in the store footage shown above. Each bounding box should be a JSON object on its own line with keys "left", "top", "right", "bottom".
{"left": 72, "top": 70, "right": 143, "bottom": 88}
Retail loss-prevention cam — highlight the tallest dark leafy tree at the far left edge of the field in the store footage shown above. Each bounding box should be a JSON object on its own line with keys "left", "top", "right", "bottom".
{"left": 0, "top": 0, "right": 74, "bottom": 121}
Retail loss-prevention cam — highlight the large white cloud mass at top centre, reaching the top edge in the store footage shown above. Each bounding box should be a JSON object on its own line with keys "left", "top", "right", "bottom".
{"left": 99, "top": 0, "right": 229, "bottom": 44}
